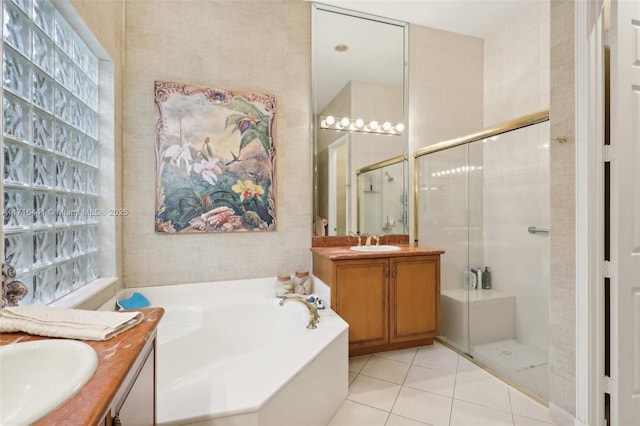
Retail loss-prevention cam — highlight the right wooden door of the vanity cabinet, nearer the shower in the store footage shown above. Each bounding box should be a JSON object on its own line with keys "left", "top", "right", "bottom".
{"left": 390, "top": 256, "right": 440, "bottom": 343}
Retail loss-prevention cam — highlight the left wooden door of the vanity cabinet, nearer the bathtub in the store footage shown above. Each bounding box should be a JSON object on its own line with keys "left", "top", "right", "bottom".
{"left": 332, "top": 259, "right": 389, "bottom": 348}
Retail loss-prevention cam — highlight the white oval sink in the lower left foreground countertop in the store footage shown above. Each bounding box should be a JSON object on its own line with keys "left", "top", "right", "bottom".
{"left": 0, "top": 339, "right": 98, "bottom": 425}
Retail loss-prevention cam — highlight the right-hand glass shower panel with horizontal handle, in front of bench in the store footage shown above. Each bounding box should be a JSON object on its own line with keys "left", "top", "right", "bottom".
{"left": 469, "top": 122, "right": 550, "bottom": 400}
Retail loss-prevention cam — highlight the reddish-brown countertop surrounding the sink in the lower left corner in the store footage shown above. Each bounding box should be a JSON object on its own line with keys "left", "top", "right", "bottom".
{"left": 0, "top": 308, "right": 164, "bottom": 425}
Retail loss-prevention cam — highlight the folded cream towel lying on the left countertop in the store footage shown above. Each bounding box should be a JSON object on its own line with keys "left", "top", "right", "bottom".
{"left": 0, "top": 305, "right": 144, "bottom": 340}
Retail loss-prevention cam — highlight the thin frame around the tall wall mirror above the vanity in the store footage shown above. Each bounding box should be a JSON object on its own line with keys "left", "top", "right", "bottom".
{"left": 311, "top": 2, "right": 411, "bottom": 237}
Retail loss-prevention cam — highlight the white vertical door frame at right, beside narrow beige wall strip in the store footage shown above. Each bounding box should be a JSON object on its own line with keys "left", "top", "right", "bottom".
{"left": 576, "top": 0, "right": 604, "bottom": 425}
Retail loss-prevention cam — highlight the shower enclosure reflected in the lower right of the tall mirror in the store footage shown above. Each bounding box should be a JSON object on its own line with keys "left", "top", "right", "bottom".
{"left": 356, "top": 155, "right": 407, "bottom": 235}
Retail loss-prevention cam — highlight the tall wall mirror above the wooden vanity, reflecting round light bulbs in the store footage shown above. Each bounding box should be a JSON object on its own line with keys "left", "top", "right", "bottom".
{"left": 312, "top": 3, "right": 408, "bottom": 236}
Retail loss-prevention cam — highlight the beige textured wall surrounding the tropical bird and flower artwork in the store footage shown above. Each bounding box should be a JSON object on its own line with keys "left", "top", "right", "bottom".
{"left": 123, "top": 0, "right": 312, "bottom": 287}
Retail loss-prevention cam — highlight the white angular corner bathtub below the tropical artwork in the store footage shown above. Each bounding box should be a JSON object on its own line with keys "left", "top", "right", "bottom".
{"left": 111, "top": 279, "right": 348, "bottom": 426}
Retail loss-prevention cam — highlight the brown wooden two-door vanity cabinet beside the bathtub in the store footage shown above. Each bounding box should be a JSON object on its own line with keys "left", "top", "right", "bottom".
{"left": 313, "top": 251, "right": 440, "bottom": 356}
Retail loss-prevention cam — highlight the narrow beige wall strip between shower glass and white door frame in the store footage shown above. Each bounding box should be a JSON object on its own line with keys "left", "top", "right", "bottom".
{"left": 549, "top": 0, "right": 576, "bottom": 414}
